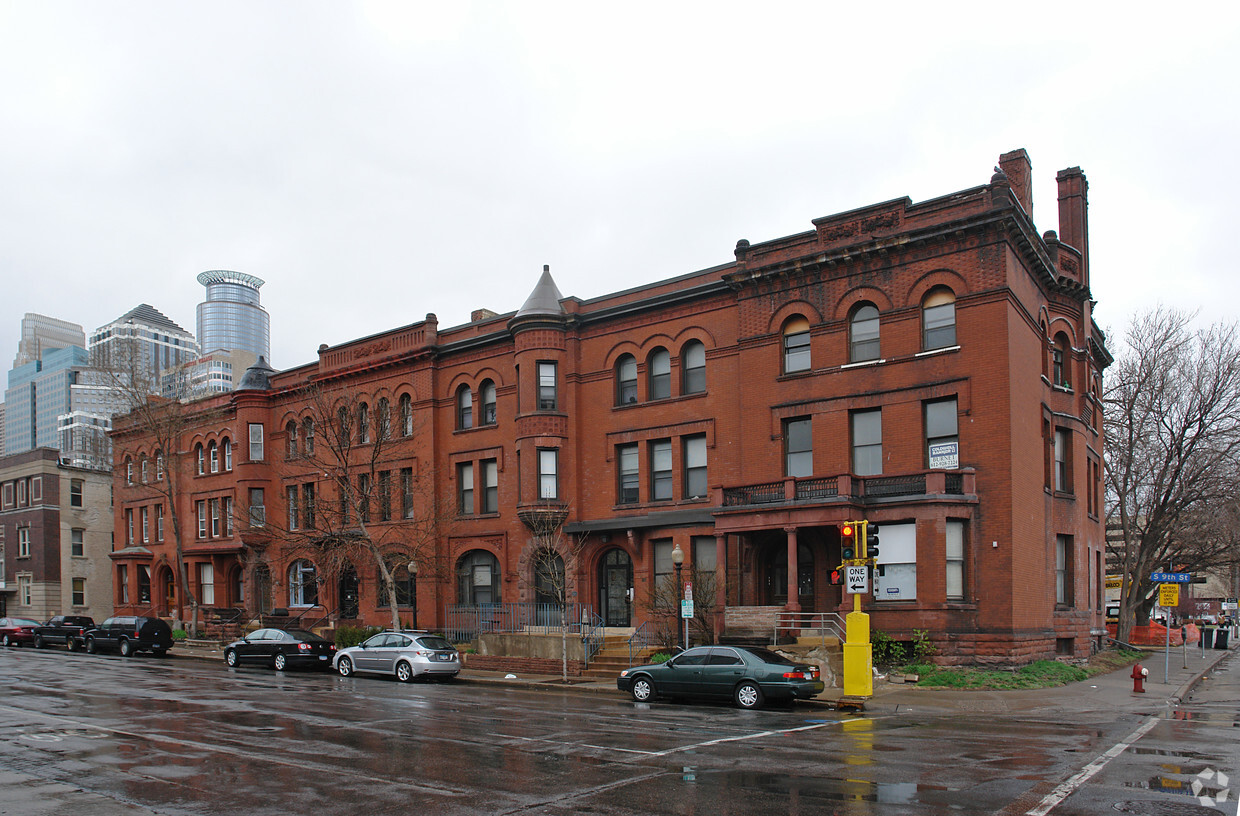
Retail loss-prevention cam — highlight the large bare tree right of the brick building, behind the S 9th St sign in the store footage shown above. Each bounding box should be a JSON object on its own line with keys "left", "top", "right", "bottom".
{"left": 1104, "top": 308, "right": 1240, "bottom": 640}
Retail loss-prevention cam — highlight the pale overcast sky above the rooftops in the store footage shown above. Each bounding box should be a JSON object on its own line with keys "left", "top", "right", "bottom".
{"left": 0, "top": 0, "right": 1240, "bottom": 370}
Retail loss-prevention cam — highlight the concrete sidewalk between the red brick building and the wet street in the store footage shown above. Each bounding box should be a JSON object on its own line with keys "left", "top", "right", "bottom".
{"left": 172, "top": 644, "right": 1233, "bottom": 713}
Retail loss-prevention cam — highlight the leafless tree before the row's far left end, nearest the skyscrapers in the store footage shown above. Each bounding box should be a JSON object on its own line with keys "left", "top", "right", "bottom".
{"left": 92, "top": 340, "right": 205, "bottom": 637}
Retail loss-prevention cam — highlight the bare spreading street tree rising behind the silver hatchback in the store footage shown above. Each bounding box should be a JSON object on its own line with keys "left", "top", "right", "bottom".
{"left": 272, "top": 383, "right": 448, "bottom": 629}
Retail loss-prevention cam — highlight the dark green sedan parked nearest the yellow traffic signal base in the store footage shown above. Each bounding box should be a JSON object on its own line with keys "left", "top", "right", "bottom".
{"left": 616, "top": 646, "right": 825, "bottom": 708}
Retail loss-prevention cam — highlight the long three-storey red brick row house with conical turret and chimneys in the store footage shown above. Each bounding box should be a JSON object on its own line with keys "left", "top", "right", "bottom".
{"left": 113, "top": 150, "right": 1111, "bottom": 661}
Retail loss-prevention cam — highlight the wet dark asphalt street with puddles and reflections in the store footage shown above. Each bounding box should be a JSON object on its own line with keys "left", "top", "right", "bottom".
{"left": 0, "top": 649, "right": 1240, "bottom": 816}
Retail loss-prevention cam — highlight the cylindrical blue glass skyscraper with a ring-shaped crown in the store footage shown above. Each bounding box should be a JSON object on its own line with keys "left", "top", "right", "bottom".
{"left": 198, "top": 269, "right": 272, "bottom": 361}
